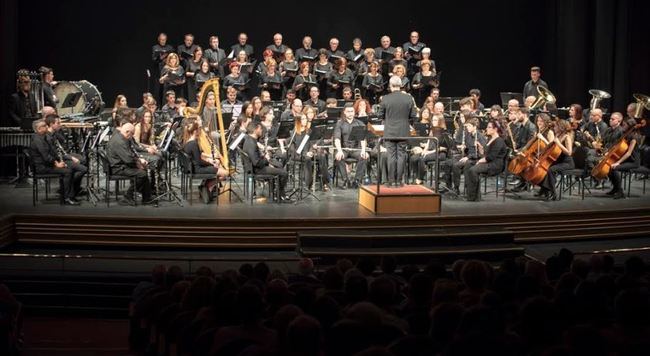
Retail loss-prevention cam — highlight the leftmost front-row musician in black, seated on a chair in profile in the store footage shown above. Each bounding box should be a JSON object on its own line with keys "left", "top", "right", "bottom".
{"left": 30, "top": 119, "right": 81, "bottom": 205}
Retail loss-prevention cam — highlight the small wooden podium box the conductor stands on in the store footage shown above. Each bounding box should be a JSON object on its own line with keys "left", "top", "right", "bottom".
{"left": 359, "top": 184, "right": 440, "bottom": 215}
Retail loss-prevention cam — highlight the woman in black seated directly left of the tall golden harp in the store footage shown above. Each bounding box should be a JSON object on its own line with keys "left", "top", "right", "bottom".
{"left": 183, "top": 120, "right": 228, "bottom": 204}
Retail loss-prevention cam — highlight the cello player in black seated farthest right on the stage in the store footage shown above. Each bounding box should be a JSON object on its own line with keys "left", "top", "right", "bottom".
{"left": 607, "top": 118, "right": 642, "bottom": 199}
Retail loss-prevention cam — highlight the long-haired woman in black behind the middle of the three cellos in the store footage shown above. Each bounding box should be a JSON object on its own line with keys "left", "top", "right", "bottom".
{"left": 537, "top": 120, "right": 575, "bottom": 200}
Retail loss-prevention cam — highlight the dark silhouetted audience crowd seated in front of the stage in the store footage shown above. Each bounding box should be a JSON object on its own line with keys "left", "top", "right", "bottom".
{"left": 119, "top": 250, "right": 650, "bottom": 356}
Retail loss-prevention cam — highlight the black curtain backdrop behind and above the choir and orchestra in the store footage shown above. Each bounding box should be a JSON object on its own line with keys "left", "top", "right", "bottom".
{"left": 0, "top": 0, "right": 650, "bottom": 123}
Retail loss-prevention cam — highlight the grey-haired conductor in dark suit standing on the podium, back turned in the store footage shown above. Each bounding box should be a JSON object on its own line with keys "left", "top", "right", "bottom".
{"left": 377, "top": 76, "right": 417, "bottom": 187}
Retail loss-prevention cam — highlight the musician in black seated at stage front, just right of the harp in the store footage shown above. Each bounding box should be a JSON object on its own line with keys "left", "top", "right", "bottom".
{"left": 243, "top": 122, "right": 290, "bottom": 201}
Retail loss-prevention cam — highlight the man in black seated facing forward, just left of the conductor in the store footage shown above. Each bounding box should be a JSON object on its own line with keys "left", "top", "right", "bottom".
{"left": 333, "top": 105, "right": 369, "bottom": 189}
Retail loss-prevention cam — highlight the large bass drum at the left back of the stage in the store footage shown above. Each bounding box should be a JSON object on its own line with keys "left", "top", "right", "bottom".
{"left": 54, "top": 80, "right": 104, "bottom": 116}
